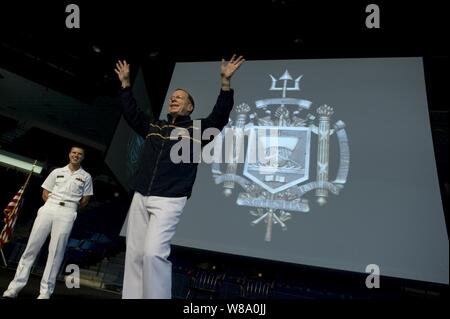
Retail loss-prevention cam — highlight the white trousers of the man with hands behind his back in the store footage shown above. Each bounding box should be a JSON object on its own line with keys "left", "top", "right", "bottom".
{"left": 8, "top": 202, "right": 77, "bottom": 295}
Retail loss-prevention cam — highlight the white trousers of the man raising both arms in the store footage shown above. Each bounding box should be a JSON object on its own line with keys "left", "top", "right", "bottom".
{"left": 122, "top": 192, "right": 187, "bottom": 299}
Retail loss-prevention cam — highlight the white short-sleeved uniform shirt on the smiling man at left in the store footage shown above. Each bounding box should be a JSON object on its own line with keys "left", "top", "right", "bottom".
{"left": 42, "top": 165, "right": 93, "bottom": 204}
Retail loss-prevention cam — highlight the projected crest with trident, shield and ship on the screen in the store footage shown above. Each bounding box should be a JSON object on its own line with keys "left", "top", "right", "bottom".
{"left": 212, "top": 70, "right": 350, "bottom": 241}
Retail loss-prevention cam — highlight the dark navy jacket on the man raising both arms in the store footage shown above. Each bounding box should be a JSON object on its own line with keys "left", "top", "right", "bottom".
{"left": 120, "top": 88, "right": 234, "bottom": 198}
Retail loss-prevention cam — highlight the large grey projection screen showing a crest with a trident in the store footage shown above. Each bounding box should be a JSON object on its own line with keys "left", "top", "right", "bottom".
{"left": 112, "top": 57, "right": 449, "bottom": 284}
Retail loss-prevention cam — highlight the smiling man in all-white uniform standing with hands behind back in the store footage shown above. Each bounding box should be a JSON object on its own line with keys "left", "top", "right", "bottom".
{"left": 3, "top": 146, "right": 93, "bottom": 299}
